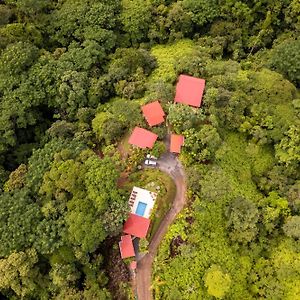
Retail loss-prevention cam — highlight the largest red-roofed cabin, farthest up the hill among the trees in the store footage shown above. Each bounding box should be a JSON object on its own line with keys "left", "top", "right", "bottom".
{"left": 175, "top": 75, "right": 205, "bottom": 107}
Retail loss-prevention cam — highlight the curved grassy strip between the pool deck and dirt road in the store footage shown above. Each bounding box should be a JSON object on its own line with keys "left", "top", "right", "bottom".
{"left": 124, "top": 169, "right": 176, "bottom": 240}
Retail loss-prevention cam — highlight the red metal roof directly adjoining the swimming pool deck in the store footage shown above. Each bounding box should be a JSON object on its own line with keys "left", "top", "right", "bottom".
{"left": 123, "top": 214, "right": 150, "bottom": 238}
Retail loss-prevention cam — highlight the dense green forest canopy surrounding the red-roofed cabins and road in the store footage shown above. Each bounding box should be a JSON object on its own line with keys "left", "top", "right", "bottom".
{"left": 0, "top": 0, "right": 300, "bottom": 300}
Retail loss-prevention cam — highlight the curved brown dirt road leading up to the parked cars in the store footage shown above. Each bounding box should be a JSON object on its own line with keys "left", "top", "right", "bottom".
{"left": 136, "top": 153, "right": 186, "bottom": 300}
